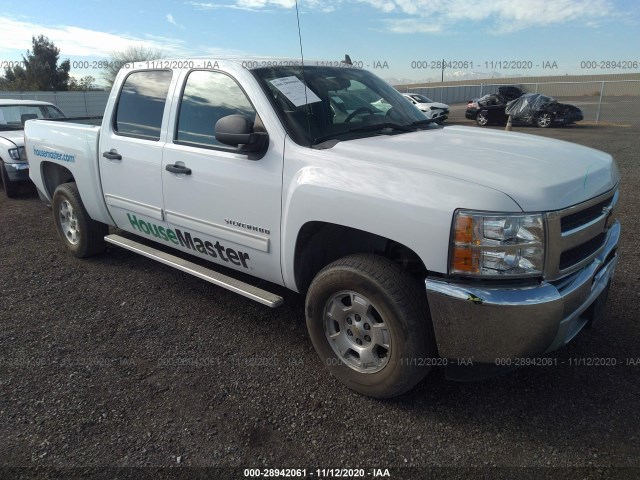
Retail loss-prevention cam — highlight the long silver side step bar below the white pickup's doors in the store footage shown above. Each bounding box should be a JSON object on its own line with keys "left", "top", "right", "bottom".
{"left": 104, "top": 235, "right": 284, "bottom": 308}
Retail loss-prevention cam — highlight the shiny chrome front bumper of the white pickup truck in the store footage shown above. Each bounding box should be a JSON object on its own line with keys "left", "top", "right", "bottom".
{"left": 425, "top": 222, "right": 620, "bottom": 364}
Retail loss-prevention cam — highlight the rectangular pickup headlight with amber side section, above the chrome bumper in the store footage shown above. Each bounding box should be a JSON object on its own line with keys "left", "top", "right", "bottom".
{"left": 449, "top": 210, "right": 544, "bottom": 277}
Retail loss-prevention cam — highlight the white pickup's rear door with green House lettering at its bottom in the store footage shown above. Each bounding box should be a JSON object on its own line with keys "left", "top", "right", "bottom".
{"left": 98, "top": 70, "right": 177, "bottom": 234}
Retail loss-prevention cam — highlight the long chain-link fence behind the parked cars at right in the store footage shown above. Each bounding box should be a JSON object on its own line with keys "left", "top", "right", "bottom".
{"left": 402, "top": 80, "right": 640, "bottom": 125}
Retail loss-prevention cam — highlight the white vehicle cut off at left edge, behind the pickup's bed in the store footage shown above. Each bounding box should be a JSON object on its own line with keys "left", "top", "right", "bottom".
{"left": 0, "top": 99, "right": 64, "bottom": 198}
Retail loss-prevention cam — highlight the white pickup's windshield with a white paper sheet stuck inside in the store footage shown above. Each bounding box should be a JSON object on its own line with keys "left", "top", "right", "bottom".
{"left": 252, "top": 66, "right": 430, "bottom": 146}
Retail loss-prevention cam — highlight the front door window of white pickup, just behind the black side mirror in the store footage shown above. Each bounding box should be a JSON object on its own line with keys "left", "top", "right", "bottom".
{"left": 175, "top": 70, "right": 256, "bottom": 148}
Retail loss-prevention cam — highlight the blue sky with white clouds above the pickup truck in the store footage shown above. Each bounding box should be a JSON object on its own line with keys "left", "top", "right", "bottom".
{"left": 0, "top": 0, "right": 640, "bottom": 84}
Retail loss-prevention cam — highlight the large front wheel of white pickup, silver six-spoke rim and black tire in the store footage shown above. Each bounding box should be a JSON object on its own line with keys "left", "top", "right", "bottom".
{"left": 305, "top": 254, "right": 437, "bottom": 398}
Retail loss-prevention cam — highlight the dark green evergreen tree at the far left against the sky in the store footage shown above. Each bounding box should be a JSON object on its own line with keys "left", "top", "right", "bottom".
{"left": 2, "top": 35, "right": 71, "bottom": 91}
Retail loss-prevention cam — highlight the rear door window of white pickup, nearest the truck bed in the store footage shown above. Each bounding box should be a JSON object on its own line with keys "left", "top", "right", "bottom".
{"left": 113, "top": 70, "right": 172, "bottom": 140}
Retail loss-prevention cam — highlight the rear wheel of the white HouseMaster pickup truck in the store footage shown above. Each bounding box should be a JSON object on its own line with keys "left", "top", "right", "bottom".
{"left": 51, "top": 182, "right": 109, "bottom": 258}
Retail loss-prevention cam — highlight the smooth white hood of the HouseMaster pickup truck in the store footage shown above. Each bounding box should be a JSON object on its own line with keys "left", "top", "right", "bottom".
{"left": 331, "top": 126, "right": 619, "bottom": 212}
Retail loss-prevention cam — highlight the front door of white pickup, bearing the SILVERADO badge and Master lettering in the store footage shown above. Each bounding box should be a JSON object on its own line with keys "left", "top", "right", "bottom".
{"left": 161, "top": 70, "right": 283, "bottom": 284}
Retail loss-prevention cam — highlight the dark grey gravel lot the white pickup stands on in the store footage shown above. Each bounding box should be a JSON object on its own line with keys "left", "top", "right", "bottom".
{"left": 0, "top": 121, "right": 640, "bottom": 478}
